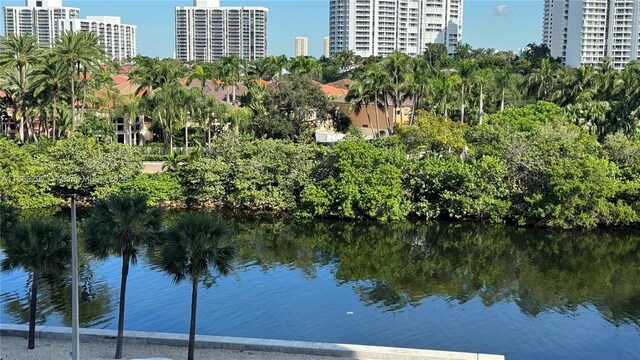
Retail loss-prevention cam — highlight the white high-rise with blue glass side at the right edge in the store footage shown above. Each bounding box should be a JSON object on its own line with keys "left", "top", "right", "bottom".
{"left": 542, "top": 0, "right": 640, "bottom": 69}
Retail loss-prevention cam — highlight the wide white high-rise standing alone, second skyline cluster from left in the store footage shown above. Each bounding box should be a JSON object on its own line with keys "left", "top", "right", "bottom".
{"left": 176, "top": 0, "right": 269, "bottom": 62}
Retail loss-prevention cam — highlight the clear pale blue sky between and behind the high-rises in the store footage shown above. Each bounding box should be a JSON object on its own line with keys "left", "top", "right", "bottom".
{"left": 0, "top": 0, "right": 543, "bottom": 57}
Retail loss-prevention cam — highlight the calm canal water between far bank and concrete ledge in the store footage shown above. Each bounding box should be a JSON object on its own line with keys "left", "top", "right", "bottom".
{"left": 0, "top": 215, "right": 640, "bottom": 360}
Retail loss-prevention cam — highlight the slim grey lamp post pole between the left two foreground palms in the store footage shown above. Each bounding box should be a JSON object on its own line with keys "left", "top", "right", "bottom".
{"left": 71, "top": 194, "right": 80, "bottom": 360}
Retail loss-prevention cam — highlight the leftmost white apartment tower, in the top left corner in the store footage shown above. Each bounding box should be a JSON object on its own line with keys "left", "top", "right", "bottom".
{"left": 3, "top": 0, "right": 80, "bottom": 47}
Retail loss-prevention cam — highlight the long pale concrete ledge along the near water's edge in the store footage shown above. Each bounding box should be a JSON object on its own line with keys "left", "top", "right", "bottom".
{"left": 0, "top": 324, "right": 505, "bottom": 360}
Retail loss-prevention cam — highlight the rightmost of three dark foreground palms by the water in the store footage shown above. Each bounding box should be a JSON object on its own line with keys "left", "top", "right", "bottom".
{"left": 161, "top": 213, "right": 236, "bottom": 360}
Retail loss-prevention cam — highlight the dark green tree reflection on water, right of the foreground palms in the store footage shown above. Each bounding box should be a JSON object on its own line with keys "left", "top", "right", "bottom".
{"left": 229, "top": 220, "right": 640, "bottom": 326}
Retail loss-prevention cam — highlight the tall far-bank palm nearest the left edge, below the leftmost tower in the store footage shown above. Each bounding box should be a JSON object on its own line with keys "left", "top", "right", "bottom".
{"left": 0, "top": 34, "right": 41, "bottom": 142}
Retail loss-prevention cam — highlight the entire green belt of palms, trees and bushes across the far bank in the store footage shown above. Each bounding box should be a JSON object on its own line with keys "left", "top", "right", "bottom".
{"left": 0, "top": 34, "right": 640, "bottom": 228}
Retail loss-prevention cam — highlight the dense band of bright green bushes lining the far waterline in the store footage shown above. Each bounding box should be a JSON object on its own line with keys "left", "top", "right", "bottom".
{"left": 5, "top": 108, "right": 640, "bottom": 228}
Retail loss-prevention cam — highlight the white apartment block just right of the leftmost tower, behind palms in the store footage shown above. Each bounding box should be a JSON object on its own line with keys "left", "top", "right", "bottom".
{"left": 57, "top": 16, "right": 138, "bottom": 60}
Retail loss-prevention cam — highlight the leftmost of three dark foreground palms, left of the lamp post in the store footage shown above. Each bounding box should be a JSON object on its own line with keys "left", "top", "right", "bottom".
{"left": 0, "top": 218, "right": 71, "bottom": 349}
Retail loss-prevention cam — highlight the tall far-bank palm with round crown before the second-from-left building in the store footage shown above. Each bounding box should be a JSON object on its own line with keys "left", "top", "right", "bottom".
{"left": 53, "top": 32, "right": 105, "bottom": 131}
